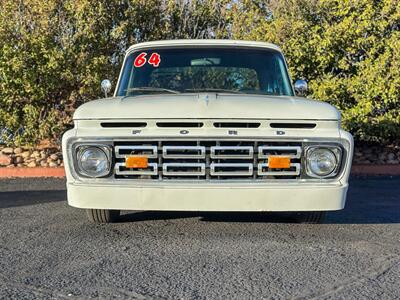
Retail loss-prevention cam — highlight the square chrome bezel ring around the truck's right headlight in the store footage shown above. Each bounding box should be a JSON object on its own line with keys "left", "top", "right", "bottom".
{"left": 303, "top": 144, "right": 345, "bottom": 179}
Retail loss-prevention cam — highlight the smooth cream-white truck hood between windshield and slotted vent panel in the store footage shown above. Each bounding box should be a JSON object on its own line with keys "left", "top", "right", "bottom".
{"left": 74, "top": 93, "right": 340, "bottom": 120}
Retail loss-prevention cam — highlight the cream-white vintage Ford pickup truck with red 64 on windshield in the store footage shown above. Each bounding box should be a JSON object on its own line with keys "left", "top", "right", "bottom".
{"left": 63, "top": 40, "right": 353, "bottom": 223}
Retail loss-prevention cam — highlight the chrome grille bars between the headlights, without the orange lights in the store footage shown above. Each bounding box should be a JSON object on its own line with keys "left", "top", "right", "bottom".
{"left": 114, "top": 141, "right": 302, "bottom": 180}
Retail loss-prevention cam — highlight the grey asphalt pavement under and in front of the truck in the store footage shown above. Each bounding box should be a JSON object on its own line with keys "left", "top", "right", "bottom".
{"left": 0, "top": 177, "right": 400, "bottom": 299}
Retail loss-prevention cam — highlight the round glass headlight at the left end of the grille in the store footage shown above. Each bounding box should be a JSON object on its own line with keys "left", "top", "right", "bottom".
{"left": 78, "top": 146, "right": 110, "bottom": 177}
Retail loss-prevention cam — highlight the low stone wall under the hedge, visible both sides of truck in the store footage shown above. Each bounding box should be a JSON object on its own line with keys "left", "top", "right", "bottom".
{"left": 0, "top": 144, "right": 400, "bottom": 168}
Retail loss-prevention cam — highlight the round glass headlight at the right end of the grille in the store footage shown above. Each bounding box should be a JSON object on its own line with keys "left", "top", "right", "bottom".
{"left": 307, "top": 148, "right": 338, "bottom": 177}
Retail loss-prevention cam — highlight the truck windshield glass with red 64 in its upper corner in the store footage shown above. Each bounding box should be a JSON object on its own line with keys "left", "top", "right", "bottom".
{"left": 117, "top": 48, "right": 293, "bottom": 96}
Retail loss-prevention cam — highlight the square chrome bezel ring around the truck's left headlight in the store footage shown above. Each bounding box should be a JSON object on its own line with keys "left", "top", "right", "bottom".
{"left": 73, "top": 143, "right": 113, "bottom": 179}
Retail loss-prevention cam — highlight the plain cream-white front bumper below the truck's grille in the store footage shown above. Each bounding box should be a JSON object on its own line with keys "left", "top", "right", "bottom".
{"left": 67, "top": 183, "right": 348, "bottom": 211}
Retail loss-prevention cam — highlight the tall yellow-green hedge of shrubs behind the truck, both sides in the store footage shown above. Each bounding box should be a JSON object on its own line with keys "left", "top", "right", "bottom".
{"left": 0, "top": 0, "right": 400, "bottom": 144}
